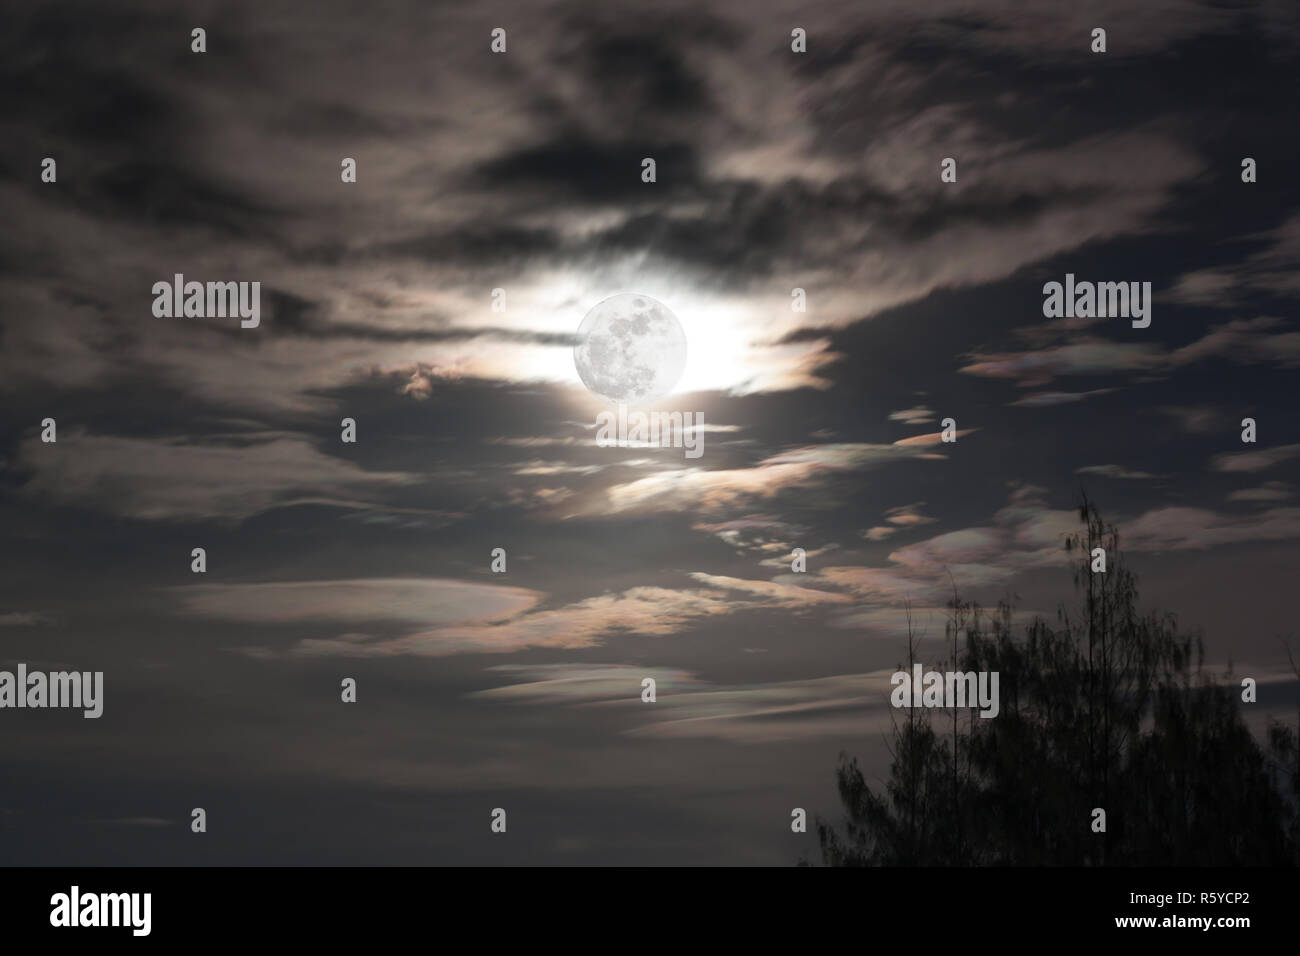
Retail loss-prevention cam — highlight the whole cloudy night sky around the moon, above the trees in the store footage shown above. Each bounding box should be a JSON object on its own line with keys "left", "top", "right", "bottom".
{"left": 0, "top": 0, "right": 1300, "bottom": 864}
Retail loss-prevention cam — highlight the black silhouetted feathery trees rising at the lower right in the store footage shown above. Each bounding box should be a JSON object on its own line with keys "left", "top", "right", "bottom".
{"left": 818, "top": 498, "right": 1300, "bottom": 866}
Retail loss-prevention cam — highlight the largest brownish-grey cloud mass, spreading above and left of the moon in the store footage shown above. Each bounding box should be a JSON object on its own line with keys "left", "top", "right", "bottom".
{"left": 0, "top": 4, "right": 1222, "bottom": 424}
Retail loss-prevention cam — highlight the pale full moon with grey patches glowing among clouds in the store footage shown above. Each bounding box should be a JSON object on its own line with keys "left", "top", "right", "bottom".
{"left": 573, "top": 293, "right": 686, "bottom": 405}
